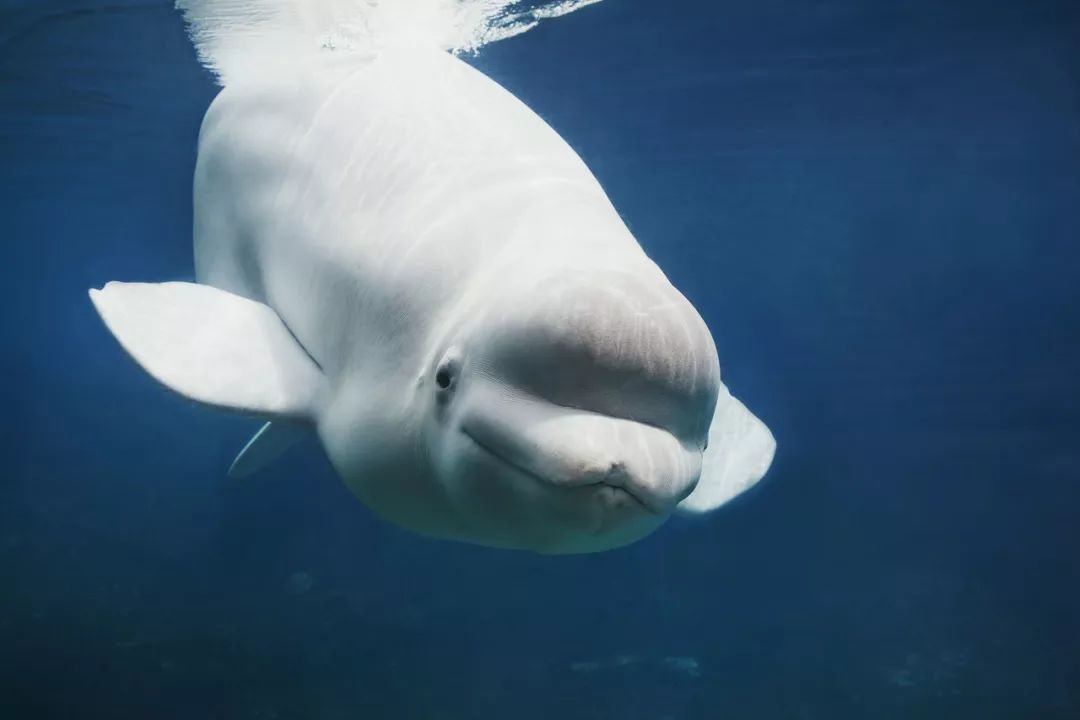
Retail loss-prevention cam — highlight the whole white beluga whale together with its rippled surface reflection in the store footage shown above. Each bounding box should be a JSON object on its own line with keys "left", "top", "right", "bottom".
{"left": 90, "top": 0, "right": 775, "bottom": 554}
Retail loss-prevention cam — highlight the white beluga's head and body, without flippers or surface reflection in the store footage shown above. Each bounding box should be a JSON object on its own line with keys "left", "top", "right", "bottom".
{"left": 194, "top": 50, "right": 720, "bottom": 553}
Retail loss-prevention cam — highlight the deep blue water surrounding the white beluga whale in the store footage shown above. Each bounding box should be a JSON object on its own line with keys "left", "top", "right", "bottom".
{"left": 0, "top": 0, "right": 1080, "bottom": 720}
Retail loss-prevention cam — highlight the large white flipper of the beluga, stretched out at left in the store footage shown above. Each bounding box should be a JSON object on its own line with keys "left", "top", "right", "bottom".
{"left": 90, "top": 283, "right": 323, "bottom": 420}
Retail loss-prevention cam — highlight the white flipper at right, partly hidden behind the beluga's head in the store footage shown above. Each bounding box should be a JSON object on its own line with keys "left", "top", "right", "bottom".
{"left": 678, "top": 385, "right": 777, "bottom": 515}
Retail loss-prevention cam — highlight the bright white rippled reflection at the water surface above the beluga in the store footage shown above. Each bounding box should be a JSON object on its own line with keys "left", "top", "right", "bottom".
{"left": 176, "top": 0, "right": 600, "bottom": 84}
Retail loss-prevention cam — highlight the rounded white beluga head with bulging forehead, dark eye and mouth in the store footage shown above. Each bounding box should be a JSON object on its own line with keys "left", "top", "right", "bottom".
{"left": 421, "top": 267, "right": 719, "bottom": 554}
